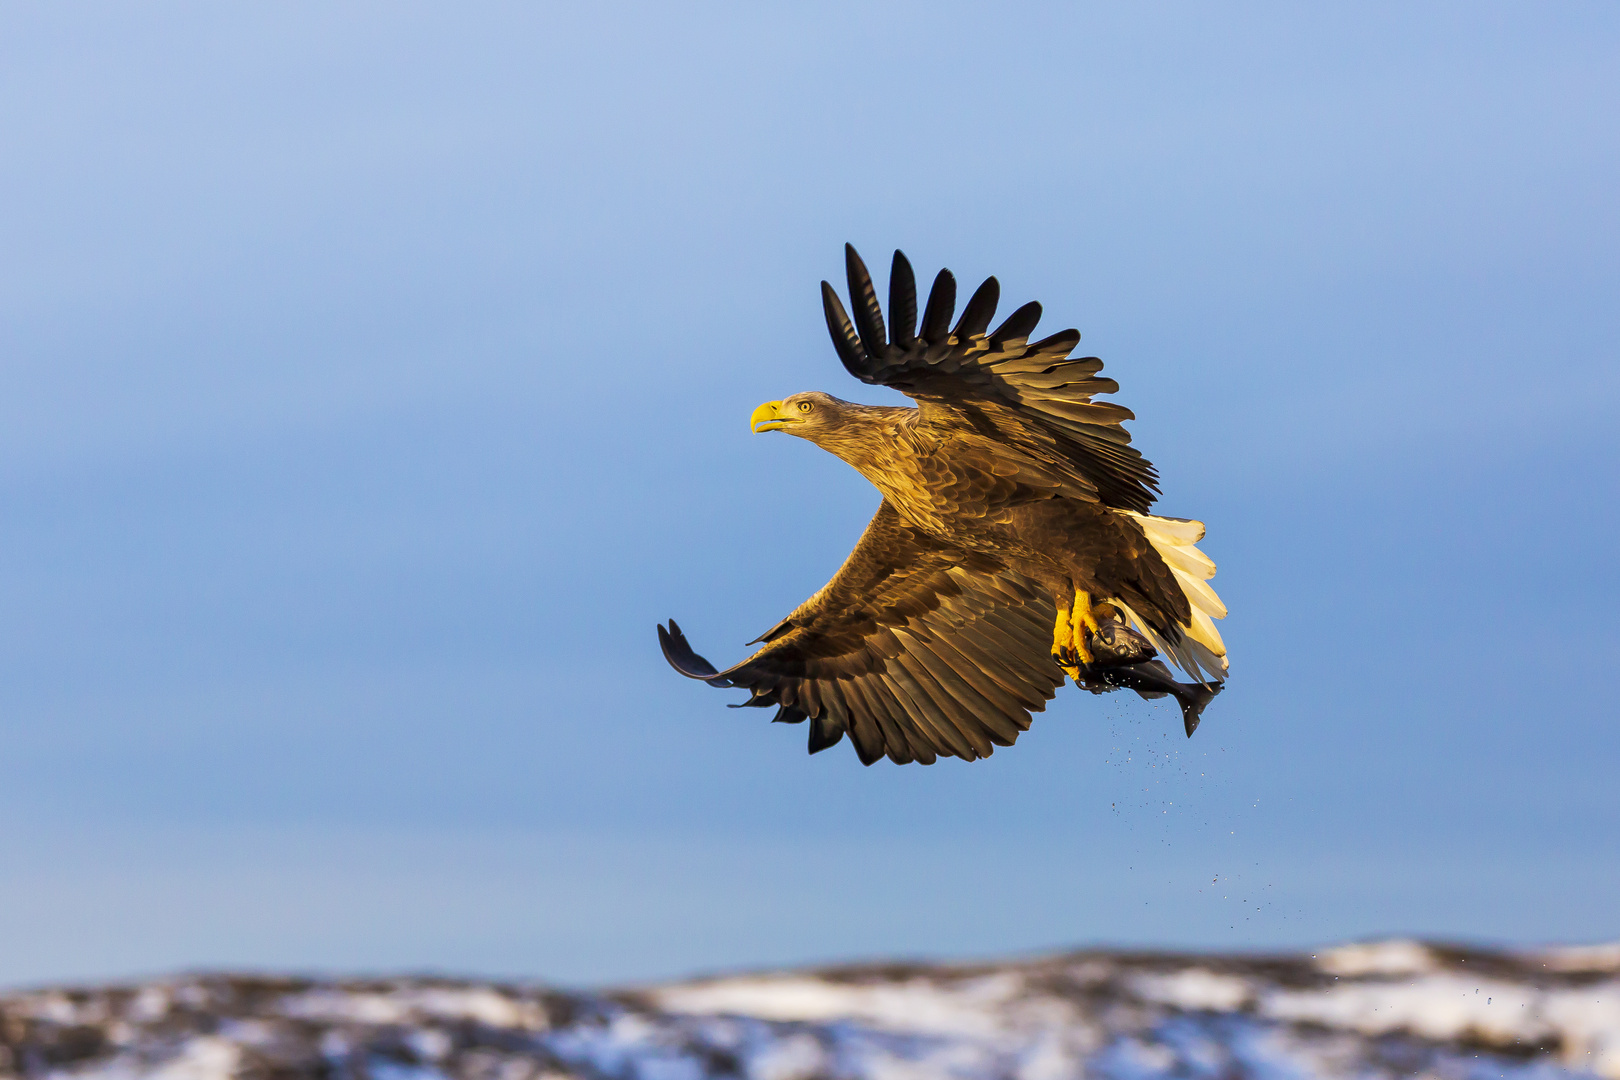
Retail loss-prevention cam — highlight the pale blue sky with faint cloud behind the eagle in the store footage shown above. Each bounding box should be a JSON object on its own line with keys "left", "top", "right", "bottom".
{"left": 0, "top": 3, "right": 1620, "bottom": 984}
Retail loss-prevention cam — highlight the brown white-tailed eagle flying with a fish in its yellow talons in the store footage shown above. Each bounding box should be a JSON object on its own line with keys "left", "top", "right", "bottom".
{"left": 658, "top": 244, "right": 1226, "bottom": 764}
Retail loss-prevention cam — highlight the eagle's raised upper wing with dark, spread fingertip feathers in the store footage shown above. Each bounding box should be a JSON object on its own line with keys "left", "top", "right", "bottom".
{"left": 821, "top": 244, "right": 1158, "bottom": 513}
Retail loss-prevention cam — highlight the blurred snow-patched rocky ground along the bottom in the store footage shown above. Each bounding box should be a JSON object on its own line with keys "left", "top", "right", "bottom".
{"left": 0, "top": 941, "right": 1620, "bottom": 1080}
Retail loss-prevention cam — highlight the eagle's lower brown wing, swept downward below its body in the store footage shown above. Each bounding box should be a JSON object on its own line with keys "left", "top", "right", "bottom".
{"left": 658, "top": 500, "right": 1063, "bottom": 764}
